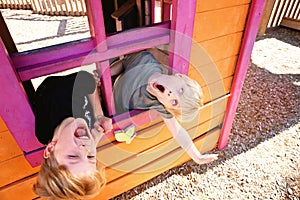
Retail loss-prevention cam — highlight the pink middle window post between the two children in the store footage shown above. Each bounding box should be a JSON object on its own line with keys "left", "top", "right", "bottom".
{"left": 86, "top": 0, "right": 115, "bottom": 115}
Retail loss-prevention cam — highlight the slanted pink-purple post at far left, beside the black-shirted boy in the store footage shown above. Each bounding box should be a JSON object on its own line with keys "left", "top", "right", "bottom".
{"left": 0, "top": 39, "right": 43, "bottom": 152}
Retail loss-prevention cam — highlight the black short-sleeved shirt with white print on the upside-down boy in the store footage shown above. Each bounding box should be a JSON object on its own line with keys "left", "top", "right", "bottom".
{"left": 33, "top": 71, "right": 96, "bottom": 144}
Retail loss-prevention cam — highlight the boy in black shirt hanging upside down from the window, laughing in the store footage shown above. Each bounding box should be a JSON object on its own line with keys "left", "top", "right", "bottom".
{"left": 33, "top": 71, "right": 112, "bottom": 199}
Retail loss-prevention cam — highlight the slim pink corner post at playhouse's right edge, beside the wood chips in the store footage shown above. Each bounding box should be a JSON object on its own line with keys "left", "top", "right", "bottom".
{"left": 218, "top": 0, "right": 265, "bottom": 149}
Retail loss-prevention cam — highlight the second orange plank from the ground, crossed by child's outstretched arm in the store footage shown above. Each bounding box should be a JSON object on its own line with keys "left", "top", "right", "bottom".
{"left": 106, "top": 113, "right": 224, "bottom": 182}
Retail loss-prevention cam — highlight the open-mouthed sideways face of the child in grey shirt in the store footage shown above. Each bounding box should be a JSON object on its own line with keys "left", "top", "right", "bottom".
{"left": 150, "top": 74, "right": 190, "bottom": 109}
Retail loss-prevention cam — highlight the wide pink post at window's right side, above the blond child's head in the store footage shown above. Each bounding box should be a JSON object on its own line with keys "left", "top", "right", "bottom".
{"left": 169, "top": 0, "right": 196, "bottom": 74}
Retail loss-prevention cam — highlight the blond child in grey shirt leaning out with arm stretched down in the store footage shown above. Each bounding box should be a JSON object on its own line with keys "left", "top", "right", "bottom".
{"left": 111, "top": 51, "right": 218, "bottom": 164}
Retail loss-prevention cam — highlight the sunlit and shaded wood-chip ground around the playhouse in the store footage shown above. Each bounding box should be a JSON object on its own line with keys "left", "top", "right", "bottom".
{"left": 1, "top": 9, "right": 300, "bottom": 200}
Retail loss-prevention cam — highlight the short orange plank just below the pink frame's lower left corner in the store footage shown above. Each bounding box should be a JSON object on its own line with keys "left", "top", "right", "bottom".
{"left": 0, "top": 155, "right": 40, "bottom": 187}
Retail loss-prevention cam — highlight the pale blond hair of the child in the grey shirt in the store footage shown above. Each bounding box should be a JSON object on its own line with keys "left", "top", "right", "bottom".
{"left": 166, "top": 74, "right": 203, "bottom": 121}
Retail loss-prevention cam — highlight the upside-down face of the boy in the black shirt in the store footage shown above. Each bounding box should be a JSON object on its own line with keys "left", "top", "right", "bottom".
{"left": 53, "top": 117, "right": 98, "bottom": 175}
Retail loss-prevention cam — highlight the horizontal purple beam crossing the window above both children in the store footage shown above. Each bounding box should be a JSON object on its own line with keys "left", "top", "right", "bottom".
{"left": 12, "top": 24, "right": 169, "bottom": 81}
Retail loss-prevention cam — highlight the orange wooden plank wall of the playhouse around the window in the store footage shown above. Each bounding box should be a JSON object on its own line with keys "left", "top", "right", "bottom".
{"left": 0, "top": 0, "right": 250, "bottom": 200}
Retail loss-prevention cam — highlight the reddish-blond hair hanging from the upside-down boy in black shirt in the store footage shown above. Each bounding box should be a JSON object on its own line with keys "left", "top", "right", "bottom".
{"left": 33, "top": 152, "right": 106, "bottom": 199}
